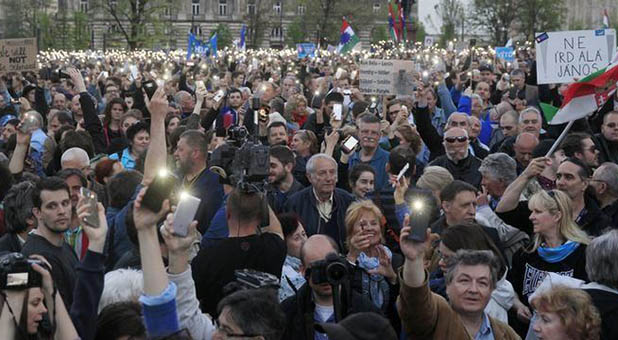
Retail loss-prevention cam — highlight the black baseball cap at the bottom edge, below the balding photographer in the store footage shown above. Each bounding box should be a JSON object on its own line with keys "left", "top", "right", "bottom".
{"left": 314, "top": 312, "right": 397, "bottom": 340}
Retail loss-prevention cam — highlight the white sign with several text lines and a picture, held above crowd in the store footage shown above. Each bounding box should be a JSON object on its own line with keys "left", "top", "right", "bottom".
{"left": 359, "top": 59, "right": 414, "bottom": 95}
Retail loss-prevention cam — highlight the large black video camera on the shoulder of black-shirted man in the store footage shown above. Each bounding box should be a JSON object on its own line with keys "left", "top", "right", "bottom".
{"left": 210, "top": 126, "right": 270, "bottom": 193}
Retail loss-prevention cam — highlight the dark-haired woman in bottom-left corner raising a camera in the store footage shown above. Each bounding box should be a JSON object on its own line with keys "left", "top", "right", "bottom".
{"left": 0, "top": 253, "right": 78, "bottom": 340}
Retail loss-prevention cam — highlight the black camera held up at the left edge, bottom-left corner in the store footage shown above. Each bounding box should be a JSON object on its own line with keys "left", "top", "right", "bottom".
{"left": 0, "top": 253, "right": 47, "bottom": 290}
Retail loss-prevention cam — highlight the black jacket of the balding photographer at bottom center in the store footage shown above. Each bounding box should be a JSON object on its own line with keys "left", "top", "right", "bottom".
{"left": 281, "top": 283, "right": 382, "bottom": 340}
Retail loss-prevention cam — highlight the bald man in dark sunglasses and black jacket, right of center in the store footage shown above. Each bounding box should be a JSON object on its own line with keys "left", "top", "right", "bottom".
{"left": 429, "top": 127, "right": 481, "bottom": 188}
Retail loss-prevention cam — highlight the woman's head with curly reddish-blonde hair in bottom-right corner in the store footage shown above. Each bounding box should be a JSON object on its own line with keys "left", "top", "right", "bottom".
{"left": 532, "top": 286, "right": 601, "bottom": 340}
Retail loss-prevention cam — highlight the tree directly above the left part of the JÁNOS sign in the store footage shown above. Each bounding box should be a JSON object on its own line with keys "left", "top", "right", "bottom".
{"left": 518, "top": 0, "right": 566, "bottom": 40}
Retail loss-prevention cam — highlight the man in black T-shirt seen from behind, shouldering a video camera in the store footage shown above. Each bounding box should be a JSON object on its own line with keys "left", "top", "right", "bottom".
{"left": 191, "top": 188, "right": 286, "bottom": 315}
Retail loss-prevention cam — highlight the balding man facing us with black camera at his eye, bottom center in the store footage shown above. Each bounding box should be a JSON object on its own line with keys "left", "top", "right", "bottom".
{"left": 281, "top": 235, "right": 380, "bottom": 340}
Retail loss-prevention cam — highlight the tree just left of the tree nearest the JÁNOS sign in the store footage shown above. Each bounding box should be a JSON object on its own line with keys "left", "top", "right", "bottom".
{"left": 469, "top": 0, "right": 520, "bottom": 46}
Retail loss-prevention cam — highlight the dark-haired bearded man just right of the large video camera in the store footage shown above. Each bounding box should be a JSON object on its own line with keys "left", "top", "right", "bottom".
{"left": 268, "top": 145, "right": 304, "bottom": 213}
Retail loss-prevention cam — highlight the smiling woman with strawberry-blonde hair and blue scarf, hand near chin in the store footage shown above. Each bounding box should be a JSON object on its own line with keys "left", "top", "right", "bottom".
{"left": 345, "top": 200, "right": 403, "bottom": 321}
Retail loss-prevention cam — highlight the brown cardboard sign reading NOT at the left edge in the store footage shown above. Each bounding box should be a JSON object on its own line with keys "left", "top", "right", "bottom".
{"left": 0, "top": 38, "right": 37, "bottom": 73}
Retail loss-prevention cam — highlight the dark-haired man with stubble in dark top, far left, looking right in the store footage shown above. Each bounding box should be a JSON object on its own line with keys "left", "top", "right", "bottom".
{"left": 22, "top": 177, "right": 78, "bottom": 306}
